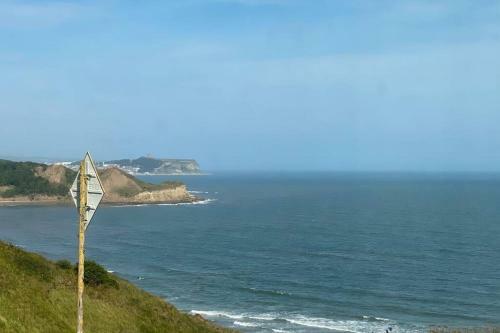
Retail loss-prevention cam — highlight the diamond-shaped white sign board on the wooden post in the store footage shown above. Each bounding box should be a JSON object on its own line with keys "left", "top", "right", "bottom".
{"left": 69, "top": 153, "right": 104, "bottom": 229}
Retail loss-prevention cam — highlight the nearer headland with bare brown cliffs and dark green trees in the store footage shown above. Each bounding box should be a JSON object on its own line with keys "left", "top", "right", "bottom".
{"left": 0, "top": 160, "right": 202, "bottom": 204}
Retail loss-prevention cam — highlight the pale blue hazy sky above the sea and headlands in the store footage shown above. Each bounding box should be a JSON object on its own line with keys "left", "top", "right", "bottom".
{"left": 0, "top": 0, "right": 500, "bottom": 171}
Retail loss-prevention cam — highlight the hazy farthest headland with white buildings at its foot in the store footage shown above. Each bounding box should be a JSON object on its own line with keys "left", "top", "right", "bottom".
{"left": 64, "top": 156, "right": 202, "bottom": 175}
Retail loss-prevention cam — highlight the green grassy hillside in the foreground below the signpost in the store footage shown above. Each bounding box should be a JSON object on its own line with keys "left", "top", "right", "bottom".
{"left": 0, "top": 242, "right": 234, "bottom": 333}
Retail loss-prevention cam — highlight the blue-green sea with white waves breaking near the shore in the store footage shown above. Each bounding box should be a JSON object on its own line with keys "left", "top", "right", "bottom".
{"left": 0, "top": 173, "right": 500, "bottom": 333}
